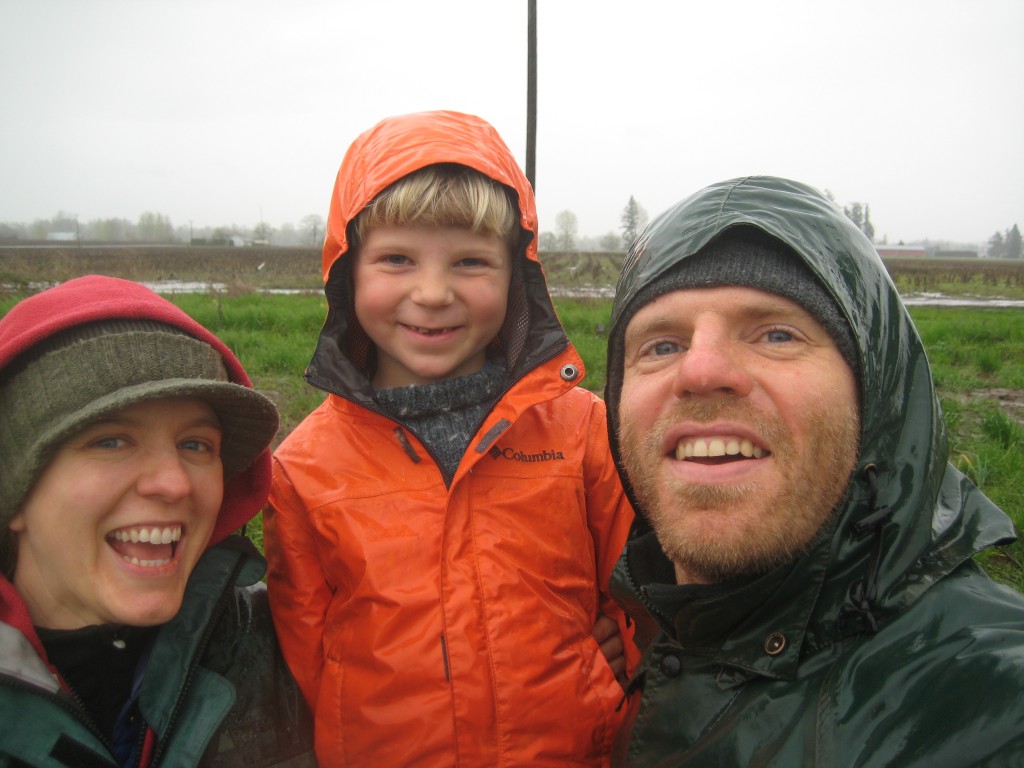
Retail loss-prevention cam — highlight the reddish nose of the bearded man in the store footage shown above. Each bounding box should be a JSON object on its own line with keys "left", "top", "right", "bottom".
{"left": 673, "top": 329, "right": 753, "bottom": 397}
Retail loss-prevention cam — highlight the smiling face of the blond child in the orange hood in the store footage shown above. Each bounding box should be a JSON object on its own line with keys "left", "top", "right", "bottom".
{"left": 352, "top": 226, "right": 512, "bottom": 387}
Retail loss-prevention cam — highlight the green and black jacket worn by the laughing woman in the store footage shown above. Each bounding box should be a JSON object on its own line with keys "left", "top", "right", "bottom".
{"left": 0, "top": 537, "right": 315, "bottom": 768}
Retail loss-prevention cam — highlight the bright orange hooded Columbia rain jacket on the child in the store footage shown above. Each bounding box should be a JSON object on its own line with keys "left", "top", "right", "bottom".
{"left": 265, "top": 113, "right": 633, "bottom": 768}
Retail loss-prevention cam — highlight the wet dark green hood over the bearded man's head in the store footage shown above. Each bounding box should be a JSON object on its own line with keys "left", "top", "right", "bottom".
{"left": 606, "top": 176, "right": 1014, "bottom": 634}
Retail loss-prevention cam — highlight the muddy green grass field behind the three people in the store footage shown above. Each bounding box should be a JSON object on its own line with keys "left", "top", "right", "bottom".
{"left": 0, "top": 248, "right": 1024, "bottom": 591}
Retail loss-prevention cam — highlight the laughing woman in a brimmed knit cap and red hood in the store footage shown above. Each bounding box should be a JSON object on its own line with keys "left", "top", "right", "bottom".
{"left": 0, "top": 276, "right": 313, "bottom": 768}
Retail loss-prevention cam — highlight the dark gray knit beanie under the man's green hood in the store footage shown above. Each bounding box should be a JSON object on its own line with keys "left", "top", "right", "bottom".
{"left": 618, "top": 227, "right": 860, "bottom": 381}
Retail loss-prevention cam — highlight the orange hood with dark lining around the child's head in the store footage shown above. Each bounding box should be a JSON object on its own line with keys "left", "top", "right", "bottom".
{"left": 306, "top": 111, "right": 568, "bottom": 408}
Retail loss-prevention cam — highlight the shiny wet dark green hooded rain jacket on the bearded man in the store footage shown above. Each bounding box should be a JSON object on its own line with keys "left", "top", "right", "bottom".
{"left": 606, "top": 177, "right": 1024, "bottom": 768}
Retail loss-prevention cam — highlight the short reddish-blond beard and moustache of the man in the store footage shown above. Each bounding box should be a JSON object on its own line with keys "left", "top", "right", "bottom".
{"left": 621, "top": 397, "right": 860, "bottom": 584}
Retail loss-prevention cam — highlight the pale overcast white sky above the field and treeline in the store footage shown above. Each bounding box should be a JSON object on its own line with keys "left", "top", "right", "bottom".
{"left": 0, "top": 0, "right": 1024, "bottom": 243}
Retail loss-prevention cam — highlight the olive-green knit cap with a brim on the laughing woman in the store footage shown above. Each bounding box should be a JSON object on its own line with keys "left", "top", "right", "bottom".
{"left": 0, "top": 319, "right": 279, "bottom": 527}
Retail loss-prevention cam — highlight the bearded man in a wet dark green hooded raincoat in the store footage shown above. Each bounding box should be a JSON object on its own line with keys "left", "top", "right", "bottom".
{"left": 606, "top": 177, "right": 1024, "bottom": 768}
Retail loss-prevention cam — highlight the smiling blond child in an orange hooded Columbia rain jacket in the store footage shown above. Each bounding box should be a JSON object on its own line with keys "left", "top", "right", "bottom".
{"left": 265, "top": 112, "right": 632, "bottom": 766}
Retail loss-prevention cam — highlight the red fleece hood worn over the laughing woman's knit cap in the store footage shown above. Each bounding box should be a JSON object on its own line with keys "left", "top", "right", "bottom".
{"left": 0, "top": 275, "right": 270, "bottom": 547}
